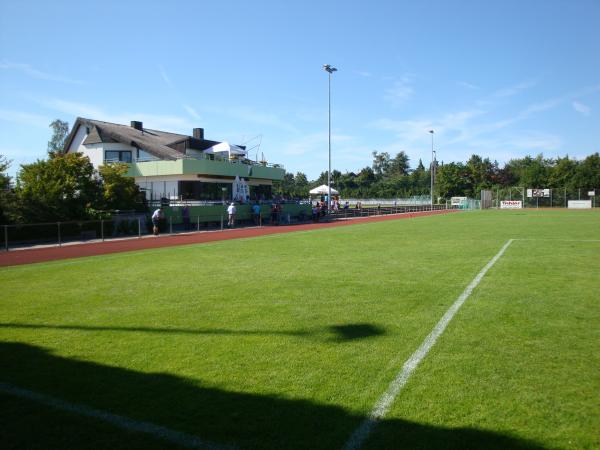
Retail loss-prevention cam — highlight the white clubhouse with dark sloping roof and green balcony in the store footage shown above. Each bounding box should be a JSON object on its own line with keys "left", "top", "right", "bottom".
{"left": 65, "top": 117, "right": 285, "bottom": 202}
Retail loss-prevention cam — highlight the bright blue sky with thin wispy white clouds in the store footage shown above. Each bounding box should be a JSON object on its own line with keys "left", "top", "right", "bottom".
{"left": 0, "top": 0, "right": 600, "bottom": 179}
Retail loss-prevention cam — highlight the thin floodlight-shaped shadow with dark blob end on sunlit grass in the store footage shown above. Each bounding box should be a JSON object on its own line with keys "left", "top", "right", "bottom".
{"left": 0, "top": 322, "right": 385, "bottom": 342}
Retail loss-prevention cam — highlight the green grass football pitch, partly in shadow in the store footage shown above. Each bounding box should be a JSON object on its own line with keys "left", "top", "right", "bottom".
{"left": 0, "top": 211, "right": 600, "bottom": 450}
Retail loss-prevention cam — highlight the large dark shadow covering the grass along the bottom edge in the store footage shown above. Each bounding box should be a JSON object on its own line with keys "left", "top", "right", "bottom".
{"left": 0, "top": 343, "right": 543, "bottom": 450}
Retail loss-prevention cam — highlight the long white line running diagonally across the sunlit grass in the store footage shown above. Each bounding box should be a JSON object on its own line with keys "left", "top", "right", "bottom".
{"left": 344, "top": 239, "right": 514, "bottom": 450}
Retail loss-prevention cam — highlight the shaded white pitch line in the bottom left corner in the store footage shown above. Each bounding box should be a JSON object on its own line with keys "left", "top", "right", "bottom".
{"left": 0, "top": 382, "right": 235, "bottom": 450}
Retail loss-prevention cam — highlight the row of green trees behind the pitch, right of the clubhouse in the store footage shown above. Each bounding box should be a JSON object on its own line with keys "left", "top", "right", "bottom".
{"left": 274, "top": 151, "right": 600, "bottom": 199}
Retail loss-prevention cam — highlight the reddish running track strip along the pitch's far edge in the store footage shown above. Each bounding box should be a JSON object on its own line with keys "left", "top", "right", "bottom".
{"left": 0, "top": 210, "right": 456, "bottom": 267}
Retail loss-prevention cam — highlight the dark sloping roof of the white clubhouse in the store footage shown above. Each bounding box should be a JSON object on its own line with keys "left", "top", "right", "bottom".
{"left": 65, "top": 117, "right": 219, "bottom": 160}
